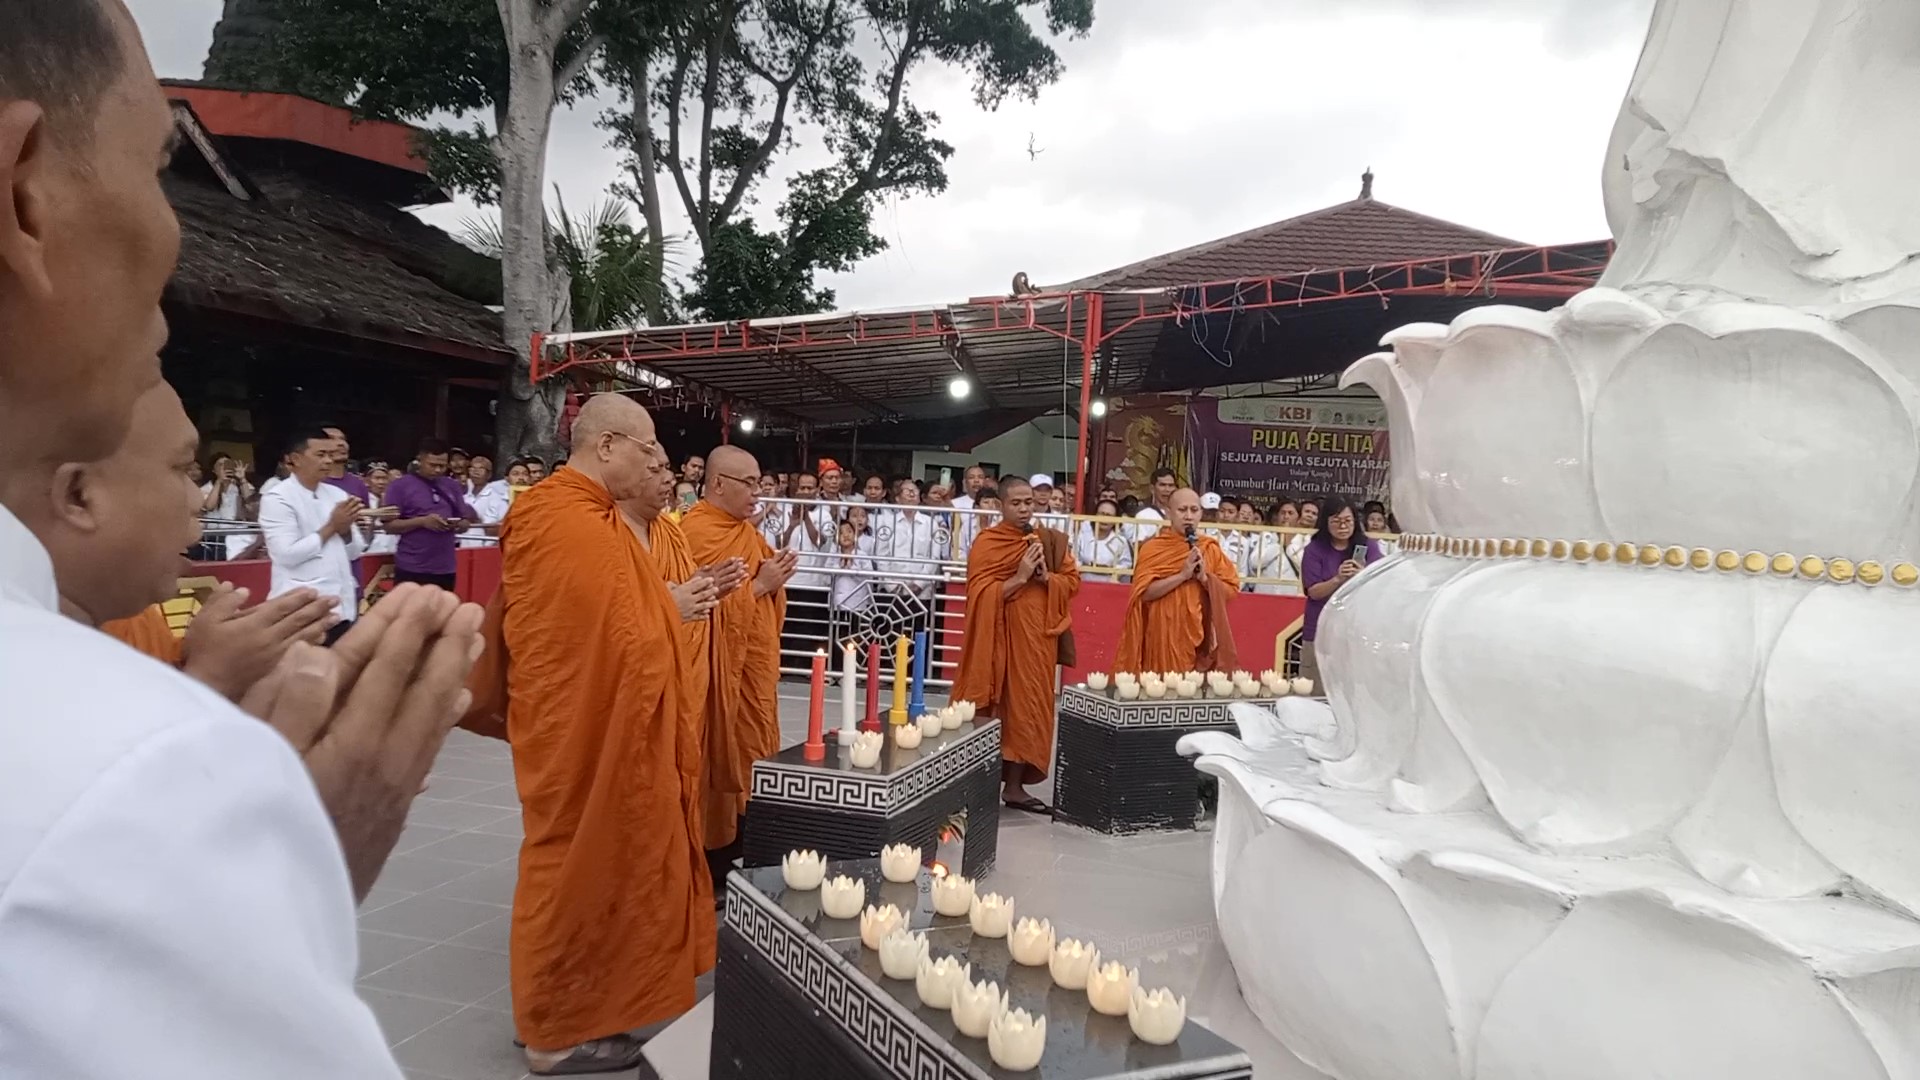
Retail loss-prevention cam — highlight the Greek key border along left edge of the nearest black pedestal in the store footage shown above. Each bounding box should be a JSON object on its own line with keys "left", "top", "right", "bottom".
{"left": 726, "top": 880, "right": 987, "bottom": 1080}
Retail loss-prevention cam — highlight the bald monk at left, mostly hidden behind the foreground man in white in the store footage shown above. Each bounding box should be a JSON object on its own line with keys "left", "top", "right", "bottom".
{"left": 38, "top": 382, "right": 336, "bottom": 701}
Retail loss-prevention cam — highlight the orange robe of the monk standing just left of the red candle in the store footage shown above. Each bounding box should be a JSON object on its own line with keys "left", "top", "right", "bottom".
{"left": 680, "top": 500, "right": 787, "bottom": 849}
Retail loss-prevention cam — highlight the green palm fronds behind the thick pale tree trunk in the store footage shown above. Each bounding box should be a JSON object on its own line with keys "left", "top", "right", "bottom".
{"left": 461, "top": 192, "right": 672, "bottom": 331}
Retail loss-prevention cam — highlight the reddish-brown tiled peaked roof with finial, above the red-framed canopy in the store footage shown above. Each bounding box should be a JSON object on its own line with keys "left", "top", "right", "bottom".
{"left": 1052, "top": 184, "right": 1524, "bottom": 290}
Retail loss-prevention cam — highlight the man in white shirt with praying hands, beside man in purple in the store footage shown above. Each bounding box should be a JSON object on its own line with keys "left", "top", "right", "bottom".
{"left": 259, "top": 430, "right": 367, "bottom": 644}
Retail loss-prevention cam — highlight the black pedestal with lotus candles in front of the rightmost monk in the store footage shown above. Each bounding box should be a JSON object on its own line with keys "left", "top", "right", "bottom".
{"left": 1054, "top": 686, "right": 1273, "bottom": 834}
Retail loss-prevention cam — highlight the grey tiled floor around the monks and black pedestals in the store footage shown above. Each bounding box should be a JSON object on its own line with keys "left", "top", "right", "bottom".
{"left": 359, "top": 686, "right": 1319, "bottom": 1080}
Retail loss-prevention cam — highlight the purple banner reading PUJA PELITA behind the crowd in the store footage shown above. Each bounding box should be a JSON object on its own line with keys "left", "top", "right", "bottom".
{"left": 1187, "top": 398, "right": 1388, "bottom": 502}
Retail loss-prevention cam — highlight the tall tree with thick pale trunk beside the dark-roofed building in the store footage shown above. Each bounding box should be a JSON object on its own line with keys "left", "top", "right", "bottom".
{"left": 207, "top": 0, "right": 606, "bottom": 457}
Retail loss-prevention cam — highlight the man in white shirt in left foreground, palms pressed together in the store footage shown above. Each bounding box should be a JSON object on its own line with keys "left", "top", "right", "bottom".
{"left": 0, "top": 0, "right": 480, "bottom": 1080}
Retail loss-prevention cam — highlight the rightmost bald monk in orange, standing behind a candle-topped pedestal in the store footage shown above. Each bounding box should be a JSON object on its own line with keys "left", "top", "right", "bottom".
{"left": 1114, "top": 488, "right": 1240, "bottom": 671}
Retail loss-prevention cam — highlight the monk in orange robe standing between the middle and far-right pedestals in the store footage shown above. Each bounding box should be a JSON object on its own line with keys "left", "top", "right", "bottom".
{"left": 952, "top": 477, "right": 1079, "bottom": 813}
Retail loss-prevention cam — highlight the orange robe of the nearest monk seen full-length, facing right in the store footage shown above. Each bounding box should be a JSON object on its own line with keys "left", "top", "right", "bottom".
{"left": 499, "top": 469, "right": 714, "bottom": 1049}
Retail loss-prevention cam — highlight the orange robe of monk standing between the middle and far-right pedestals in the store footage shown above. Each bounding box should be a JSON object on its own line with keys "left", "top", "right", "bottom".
{"left": 952, "top": 521, "right": 1079, "bottom": 772}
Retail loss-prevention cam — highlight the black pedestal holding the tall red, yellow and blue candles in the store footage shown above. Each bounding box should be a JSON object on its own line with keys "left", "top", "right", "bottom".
{"left": 741, "top": 719, "right": 1000, "bottom": 878}
